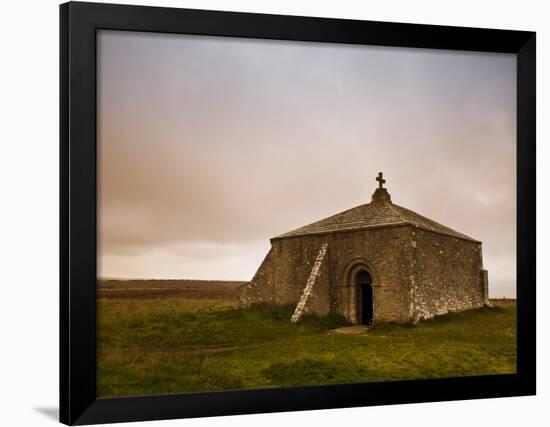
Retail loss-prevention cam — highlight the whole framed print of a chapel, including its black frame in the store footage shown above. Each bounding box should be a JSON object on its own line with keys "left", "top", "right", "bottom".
{"left": 60, "top": 2, "right": 535, "bottom": 424}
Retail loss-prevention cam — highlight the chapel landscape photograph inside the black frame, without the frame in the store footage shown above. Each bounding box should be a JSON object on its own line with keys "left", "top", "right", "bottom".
{"left": 96, "top": 29, "right": 516, "bottom": 398}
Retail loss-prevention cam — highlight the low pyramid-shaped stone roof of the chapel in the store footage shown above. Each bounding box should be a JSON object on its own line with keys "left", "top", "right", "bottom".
{"left": 274, "top": 187, "right": 478, "bottom": 242}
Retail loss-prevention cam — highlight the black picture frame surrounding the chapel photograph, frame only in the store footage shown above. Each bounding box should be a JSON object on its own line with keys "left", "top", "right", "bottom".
{"left": 60, "top": 2, "right": 536, "bottom": 425}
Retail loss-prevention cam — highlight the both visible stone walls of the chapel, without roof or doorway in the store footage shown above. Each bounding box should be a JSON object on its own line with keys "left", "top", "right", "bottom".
{"left": 241, "top": 225, "right": 488, "bottom": 322}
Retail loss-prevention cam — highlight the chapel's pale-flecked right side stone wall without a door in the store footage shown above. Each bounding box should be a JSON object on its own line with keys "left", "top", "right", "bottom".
{"left": 410, "top": 227, "right": 487, "bottom": 321}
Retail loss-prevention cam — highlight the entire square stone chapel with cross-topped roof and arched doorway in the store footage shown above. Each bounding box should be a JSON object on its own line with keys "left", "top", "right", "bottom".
{"left": 240, "top": 173, "right": 488, "bottom": 325}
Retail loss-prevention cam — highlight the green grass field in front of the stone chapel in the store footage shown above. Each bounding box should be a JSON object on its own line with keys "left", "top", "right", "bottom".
{"left": 98, "top": 299, "right": 516, "bottom": 397}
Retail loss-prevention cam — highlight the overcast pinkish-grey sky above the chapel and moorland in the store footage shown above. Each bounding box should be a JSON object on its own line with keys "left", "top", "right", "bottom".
{"left": 98, "top": 31, "right": 516, "bottom": 296}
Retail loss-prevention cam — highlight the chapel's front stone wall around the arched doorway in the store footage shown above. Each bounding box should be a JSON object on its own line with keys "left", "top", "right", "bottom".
{"left": 241, "top": 226, "right": 412, "bottom": 322}
